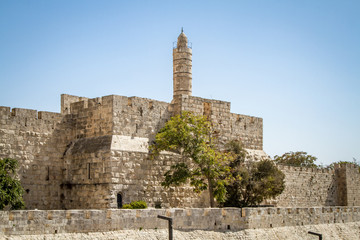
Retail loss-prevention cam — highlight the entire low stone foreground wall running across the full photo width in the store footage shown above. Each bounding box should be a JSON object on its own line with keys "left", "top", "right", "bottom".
{"left": 0, "top": 207, "right": 360, "bottom": 235}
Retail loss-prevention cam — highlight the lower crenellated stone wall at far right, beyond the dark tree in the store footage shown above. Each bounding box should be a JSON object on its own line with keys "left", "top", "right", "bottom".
{"left": 272, "top": 164, "right": 360, "bottom": 207}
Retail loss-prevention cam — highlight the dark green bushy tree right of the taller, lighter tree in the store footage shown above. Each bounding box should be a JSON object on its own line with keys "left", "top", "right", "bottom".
{"left": 223, "top": 141, "right": 285, "bottom": 207}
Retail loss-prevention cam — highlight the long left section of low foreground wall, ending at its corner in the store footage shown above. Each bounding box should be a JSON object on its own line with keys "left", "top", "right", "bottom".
{"left": 0, "top": 208, "right": 245, "bottom": 235}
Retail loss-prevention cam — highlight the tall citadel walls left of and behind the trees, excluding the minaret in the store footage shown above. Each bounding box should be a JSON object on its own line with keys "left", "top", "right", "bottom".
{"left": 0, "top": 94, "right": 268, "bottom": 209}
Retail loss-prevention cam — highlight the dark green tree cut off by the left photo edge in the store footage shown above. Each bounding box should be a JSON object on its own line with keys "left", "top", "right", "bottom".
{"left": 0, "top": 158, "right": 25, "bottom": 210}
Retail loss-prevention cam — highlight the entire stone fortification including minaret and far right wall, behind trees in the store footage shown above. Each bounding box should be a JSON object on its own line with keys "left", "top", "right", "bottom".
{"left": 0, "top": 33, "right": 360, "bottom": 209}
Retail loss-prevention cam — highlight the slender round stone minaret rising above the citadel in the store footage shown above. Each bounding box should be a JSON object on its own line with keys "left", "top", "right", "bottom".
{"left": 173, "top": 28, "right": 192, "bottom": 98}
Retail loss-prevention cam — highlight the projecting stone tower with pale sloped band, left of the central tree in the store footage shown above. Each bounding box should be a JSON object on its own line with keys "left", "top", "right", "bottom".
{"left": 62, "top": 95, "right": 208, "bottom": 209}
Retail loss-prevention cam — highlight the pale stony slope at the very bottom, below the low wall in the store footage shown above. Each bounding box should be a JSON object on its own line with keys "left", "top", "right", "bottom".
{"left": 0, "top": 222, "right": 360, "bottom": 240}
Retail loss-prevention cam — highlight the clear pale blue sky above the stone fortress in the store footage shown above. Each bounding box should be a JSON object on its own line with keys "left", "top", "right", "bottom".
{"left": 0, "top": 0, "right": 360, "bottom": 165}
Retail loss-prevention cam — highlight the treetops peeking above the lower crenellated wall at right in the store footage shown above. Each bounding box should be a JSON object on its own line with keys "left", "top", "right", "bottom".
{"left": 274, "top": 152, "right": 318, "bottom": 168}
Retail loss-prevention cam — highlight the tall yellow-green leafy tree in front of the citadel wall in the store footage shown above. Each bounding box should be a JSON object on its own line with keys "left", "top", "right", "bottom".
{"left": 150, "top": 112, "right": 229, "bottom": 207}
